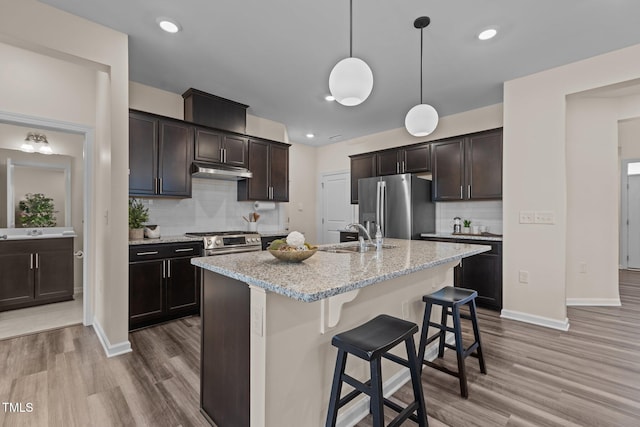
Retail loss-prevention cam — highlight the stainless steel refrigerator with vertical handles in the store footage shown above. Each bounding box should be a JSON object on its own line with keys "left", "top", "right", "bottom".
{"left": 358, "top": 173, "right": 436, "bottom": 240}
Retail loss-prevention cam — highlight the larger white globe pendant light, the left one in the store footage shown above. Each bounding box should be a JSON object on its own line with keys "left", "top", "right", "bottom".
{"left": 329, "top": 0, "right": 373, "bottom": 107}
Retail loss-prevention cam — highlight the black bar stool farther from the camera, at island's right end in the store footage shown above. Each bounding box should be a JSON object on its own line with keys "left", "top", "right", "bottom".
{"left": 418, "top": 286, "right": 487, "bottom": 399}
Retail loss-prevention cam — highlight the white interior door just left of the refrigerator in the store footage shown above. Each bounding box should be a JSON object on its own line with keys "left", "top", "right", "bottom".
{"left": 321, "top": 172, "right": 353, "bottom": 243}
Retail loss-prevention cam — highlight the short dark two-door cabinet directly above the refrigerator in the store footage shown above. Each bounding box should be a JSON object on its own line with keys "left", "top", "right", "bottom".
{"left": 376, "top": 143, "right": 431, "bottom": 176}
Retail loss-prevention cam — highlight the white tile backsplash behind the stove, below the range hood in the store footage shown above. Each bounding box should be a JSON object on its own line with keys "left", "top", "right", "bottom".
{"left": 141, "top": 178, "right": 287, "bottom": 236}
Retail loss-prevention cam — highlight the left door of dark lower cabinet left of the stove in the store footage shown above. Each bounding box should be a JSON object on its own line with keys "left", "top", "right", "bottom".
{"left": 129, "top": 259, "right": 165, "bottom": 329}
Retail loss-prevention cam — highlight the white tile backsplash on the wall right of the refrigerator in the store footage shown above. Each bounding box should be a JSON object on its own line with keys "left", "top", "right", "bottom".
{"left": 436, "top": 200, "right": 502, "bottom": 234}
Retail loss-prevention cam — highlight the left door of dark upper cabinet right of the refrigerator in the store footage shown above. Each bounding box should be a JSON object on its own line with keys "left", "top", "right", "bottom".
{"left": 431, "top": 139, "right": 464, "bottom": 201}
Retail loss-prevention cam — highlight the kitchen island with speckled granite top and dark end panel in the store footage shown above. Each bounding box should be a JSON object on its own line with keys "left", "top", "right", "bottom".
{"left": 192, "top": 239, "right": 490, "bottom": 427}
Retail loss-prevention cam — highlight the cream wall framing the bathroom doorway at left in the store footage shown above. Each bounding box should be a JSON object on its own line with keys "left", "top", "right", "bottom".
{"left": 0, "top": 0, "right": 130, "bottom": 354}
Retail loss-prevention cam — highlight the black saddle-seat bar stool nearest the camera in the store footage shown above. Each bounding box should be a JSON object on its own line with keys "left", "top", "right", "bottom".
{"left": 326, "top": 314, "right": 428, "bottom": 427}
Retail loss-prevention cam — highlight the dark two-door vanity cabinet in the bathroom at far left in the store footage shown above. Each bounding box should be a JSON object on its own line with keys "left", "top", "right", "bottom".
{"left": 0, "top": 238, "right": 73, "bottom": 311}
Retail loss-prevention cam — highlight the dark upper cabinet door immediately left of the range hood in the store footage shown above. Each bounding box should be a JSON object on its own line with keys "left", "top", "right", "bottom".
{"left": 158, "top": 121, "right": 193, "bottom": 197}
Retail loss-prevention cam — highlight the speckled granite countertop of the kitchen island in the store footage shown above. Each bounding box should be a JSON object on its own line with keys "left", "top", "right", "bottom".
{"left": 191, "top": 239, "right": 490, "bottom": 302}
